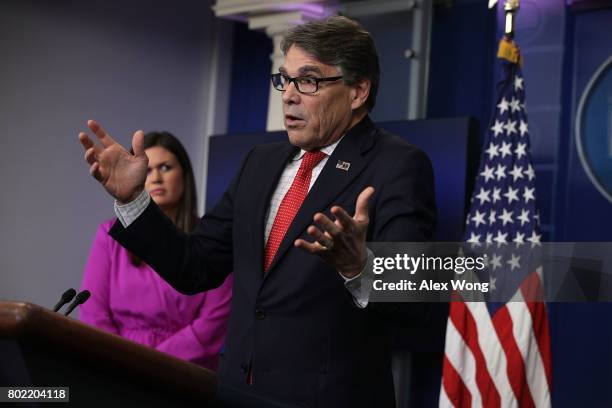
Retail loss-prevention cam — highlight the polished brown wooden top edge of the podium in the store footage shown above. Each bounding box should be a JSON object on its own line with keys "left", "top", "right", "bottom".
{"left": 0, "top": 301, "right": 218, "bottom": 401}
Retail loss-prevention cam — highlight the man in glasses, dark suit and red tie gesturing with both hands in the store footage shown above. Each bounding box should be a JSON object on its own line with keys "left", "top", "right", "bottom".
{"left": 79, "top": 17, "right": 435, "bottom": 407}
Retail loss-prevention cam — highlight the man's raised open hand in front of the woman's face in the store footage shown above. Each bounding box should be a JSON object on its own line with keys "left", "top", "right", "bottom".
{"left": 79, "top": 120, "right": 149, "bottom": 204}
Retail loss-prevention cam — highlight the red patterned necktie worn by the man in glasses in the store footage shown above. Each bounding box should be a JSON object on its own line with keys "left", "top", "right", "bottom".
{"left": 264, "top": 150, "right": 326, "bottom": 272}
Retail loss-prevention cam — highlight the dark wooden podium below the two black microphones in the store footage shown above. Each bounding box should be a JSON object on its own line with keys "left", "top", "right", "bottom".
{"left": 0, "top": 301, "right": 218, "bottom": 407}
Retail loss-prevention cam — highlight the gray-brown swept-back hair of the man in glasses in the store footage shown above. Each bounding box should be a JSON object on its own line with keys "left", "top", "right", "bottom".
{"left": 281, "top": 16, "right": 380, "bottom": 111}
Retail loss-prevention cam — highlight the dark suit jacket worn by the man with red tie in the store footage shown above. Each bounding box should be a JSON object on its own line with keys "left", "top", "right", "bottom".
{"left": 110, "top": 117, "right": 435, "bottom": 407}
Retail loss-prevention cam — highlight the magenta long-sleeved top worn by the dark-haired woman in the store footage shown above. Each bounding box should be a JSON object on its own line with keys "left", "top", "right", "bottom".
{"left": 80, "top": 220, "right": 232, "bottom": 370}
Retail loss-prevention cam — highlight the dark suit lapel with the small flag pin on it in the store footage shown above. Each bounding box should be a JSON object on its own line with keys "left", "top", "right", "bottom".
{"left": 264, "top": 116, "right": 376, "bottom": 279}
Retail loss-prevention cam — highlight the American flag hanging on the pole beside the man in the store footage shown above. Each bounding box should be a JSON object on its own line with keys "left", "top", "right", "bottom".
{"left": 439, "top": 38, "right": 551, "bottom": 408}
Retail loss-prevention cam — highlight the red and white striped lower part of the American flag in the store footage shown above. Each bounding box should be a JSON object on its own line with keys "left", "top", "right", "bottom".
{"left": 439, "top": 268, "right": 551, "bottom": 408}
